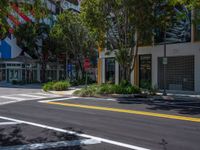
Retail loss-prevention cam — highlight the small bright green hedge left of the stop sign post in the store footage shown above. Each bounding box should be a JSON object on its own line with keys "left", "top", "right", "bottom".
{"left": 43, "top": 81, "right": 70, "bottom": 91}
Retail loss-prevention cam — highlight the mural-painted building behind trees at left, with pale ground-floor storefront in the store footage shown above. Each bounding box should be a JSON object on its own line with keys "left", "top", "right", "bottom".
{"left": 0, "top": 0, "right": 80, "bottom": 83}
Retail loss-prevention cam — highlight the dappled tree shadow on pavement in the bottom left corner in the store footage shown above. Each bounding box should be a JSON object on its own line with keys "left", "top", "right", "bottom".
{"left": 0, "top": 125, "right": 84, "bottom": 150}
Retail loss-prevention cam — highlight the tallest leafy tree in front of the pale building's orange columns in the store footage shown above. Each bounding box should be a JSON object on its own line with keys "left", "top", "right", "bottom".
{"left": 81, "top": 0, "right": 154, "bottom": 81}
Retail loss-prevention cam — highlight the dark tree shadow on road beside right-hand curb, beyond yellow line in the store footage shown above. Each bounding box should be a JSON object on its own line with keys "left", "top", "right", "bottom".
{"left": 117, "top": 98, "right": 200, "bottom": 115}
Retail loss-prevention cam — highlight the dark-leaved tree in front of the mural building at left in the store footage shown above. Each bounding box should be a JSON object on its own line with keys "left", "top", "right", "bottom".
{"left": 14, "top": 22, "right": 52, "bottom": 82}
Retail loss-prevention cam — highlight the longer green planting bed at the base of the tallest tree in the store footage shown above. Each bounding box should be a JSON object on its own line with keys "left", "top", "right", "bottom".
{"left": 74, "top": 84, "right": 141, "bottom": 96}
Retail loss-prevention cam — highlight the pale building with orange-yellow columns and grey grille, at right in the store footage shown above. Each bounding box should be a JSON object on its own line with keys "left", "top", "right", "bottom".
{"left": 98, "top": 9, "right": 200, "bottom": 93}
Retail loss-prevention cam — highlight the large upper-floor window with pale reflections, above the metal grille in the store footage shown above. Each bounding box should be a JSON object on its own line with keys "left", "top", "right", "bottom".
{"left": 155, "top": 6, "right": 191, "bottom": 44}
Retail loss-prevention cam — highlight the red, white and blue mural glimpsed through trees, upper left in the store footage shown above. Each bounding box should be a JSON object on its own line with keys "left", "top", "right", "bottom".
{"left": 0, "top": 0, "right": 80, "bottom": 59}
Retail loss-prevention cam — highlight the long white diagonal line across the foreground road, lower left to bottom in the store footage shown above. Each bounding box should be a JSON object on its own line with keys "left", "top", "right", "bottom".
{"left": 0, "top": 116, "right": 150, "bottom": 150}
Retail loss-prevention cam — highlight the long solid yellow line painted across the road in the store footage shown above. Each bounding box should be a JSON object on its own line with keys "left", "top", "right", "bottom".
{"left": 47, "top": 102, "right": 200, "bottom": 123}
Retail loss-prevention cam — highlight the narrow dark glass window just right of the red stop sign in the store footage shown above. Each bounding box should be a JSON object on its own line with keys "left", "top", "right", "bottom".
{"left": 105, "top": 58, "right": 115, "bottom": 83}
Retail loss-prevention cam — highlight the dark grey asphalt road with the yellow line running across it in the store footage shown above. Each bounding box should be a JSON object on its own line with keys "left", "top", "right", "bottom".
{"left": 0, "top": 94, "right": 200, "bottom": 150}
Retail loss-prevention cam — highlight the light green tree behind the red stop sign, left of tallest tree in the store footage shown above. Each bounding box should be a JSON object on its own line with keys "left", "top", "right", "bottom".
{"left": 51, "top": 11, "right": 95, "bottom": 78}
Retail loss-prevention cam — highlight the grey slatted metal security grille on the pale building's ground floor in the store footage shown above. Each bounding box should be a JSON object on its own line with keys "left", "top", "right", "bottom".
{"left": 158, "top": 56, "right": 194, "bottom": 91}
